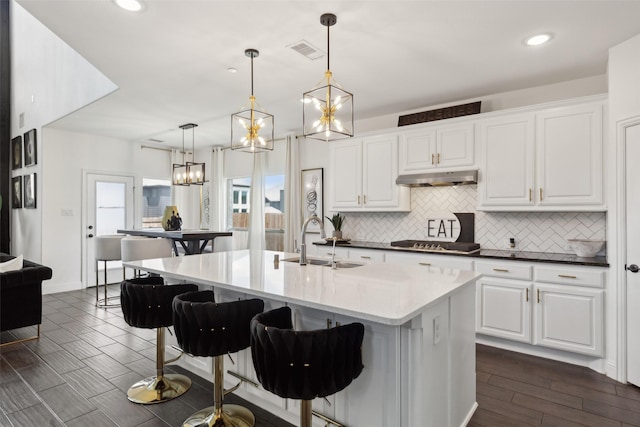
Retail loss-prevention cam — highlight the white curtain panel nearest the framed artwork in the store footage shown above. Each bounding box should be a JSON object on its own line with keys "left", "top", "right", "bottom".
{"left": 284, "top": 136, "right": 302, "bottom": 252}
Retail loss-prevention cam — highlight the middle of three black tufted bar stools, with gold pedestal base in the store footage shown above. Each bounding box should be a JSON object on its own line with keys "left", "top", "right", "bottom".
{"left": 173, "top": 291, "right": 264, "bottom": 427}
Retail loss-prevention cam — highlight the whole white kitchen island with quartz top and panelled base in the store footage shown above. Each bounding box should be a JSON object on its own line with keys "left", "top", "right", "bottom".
{"left": 124, "top": 250, "right": 479, "bottom": 427}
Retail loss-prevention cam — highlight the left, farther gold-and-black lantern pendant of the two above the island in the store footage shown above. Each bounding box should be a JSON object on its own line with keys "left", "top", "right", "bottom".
{"left": 231, "top": 49, "right": 273, "bottom": 153}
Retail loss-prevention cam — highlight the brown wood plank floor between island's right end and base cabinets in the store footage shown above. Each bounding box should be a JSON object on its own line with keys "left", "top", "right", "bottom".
{"left": 469, "top": 345, "right": 640, "bottom": 427}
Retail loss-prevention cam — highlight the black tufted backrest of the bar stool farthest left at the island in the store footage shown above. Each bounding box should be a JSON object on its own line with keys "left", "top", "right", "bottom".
{"left": 120, "top": 276, "right": 198, "bottom": 329}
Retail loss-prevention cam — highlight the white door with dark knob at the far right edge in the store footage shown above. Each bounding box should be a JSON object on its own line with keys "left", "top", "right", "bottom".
{"left": 625, "top": 125, "right": 640, "bottom": 386}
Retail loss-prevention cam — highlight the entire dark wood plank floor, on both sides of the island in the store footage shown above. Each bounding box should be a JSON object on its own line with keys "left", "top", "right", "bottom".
{"left": 0, "top": 287, "right": 640, "bottom": 427}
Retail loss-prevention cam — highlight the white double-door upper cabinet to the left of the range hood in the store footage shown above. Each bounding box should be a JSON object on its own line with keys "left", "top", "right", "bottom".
{"left": 329, "top": 134, "right": 410, "bottom": 212}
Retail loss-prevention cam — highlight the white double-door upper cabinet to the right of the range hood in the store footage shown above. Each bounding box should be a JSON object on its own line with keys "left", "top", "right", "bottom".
{"left": 478, "top": 97, "right": 606, "bottom": 211}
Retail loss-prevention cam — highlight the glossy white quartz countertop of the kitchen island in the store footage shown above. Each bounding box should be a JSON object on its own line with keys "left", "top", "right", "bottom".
{"left": 124, "top": 250, "right": 480, "bottom": 325}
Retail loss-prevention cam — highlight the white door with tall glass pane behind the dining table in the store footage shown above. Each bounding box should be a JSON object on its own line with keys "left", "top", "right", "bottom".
{"left": 83, "top": 173, "right": 134, "bottom": 287}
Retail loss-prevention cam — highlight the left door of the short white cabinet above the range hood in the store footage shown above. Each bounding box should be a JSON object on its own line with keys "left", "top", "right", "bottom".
{"left": 398, "top": 128, "right": 436, "bottom": 174}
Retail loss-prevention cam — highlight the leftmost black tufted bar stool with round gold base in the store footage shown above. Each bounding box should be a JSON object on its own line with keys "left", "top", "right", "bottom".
{"left": 120, "top": 276, "right": 198, "bottom": 404}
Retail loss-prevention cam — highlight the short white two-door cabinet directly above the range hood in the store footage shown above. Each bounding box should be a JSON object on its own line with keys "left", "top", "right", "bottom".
{"left": 399, "top": 123, "right": 474, "bottom": 174}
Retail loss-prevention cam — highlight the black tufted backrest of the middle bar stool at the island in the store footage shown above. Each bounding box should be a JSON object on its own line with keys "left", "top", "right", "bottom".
{"left": 173, "top": 291, "right": 264, "bottom": 356}
